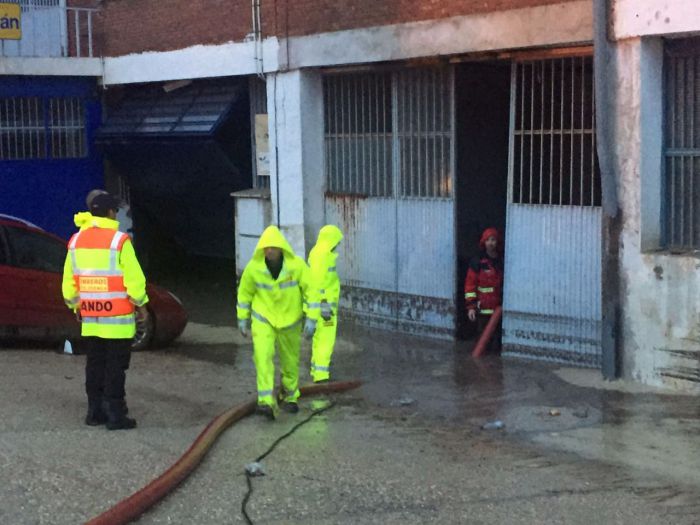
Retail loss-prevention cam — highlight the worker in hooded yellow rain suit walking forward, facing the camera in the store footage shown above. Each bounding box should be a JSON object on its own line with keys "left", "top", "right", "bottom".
{"left": 236, "top": 226, "right": 319, "bottom": 419}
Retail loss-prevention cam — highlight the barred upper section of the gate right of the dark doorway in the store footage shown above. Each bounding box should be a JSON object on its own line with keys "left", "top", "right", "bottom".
{"left": 511, "top": 57, "right": 601, "bottom": 206}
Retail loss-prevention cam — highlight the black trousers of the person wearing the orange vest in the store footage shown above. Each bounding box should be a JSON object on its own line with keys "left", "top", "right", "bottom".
{"left": 84, "top": 337, "right": 131, "bottom": 401}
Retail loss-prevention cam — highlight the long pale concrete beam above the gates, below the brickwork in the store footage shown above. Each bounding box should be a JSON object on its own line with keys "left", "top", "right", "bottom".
{"left": 98, "top": 0, "right": 593, "bottom": 85}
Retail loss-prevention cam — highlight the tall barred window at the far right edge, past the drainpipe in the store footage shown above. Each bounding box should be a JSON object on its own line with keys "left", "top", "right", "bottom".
{"left": 664, "top": 38, "right": 700, "bottom": 250}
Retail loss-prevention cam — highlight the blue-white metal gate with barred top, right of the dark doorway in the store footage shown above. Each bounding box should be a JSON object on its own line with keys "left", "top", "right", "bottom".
{"left": 503, "top": 57, "right": 602, "bottom": 367}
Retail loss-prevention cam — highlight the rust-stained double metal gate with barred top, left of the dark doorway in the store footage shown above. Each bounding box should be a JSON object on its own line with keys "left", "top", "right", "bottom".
{"left": 324, "top": 68, "right": 455, "bottom": 336}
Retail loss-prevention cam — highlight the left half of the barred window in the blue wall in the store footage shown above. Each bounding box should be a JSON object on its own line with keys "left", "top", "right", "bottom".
{"left": 0, "top": 97, "right": 46, "bottom": 160}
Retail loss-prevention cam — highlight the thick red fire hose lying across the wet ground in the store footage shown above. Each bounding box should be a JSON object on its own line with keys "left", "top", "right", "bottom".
{"left": 87, "top": 381, "right": 361, "bottom": 525}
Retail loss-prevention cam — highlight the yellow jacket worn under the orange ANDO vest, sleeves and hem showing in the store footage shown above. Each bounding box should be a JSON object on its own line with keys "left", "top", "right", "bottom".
{"left": 62, "top": 212, "right": 148, "bottom": 339}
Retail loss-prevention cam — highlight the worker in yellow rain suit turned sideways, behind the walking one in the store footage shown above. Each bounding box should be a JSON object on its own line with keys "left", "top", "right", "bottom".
{"left": 309, "top": 224, "right": 343, "bottom": 383}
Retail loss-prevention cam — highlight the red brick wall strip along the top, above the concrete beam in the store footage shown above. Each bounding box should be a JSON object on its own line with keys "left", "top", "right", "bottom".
{"left": 101, "top": 0, "right": 574, "bottom": 56}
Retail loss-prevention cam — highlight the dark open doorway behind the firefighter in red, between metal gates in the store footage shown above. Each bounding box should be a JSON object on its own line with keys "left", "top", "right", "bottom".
{"left": 455, "top": 62, "right": 510, "bottom": 338}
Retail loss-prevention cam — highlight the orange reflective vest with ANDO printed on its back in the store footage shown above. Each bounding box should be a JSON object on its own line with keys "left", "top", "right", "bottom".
{"left": 68, "top": 228, "right": 134, "bottom": 317}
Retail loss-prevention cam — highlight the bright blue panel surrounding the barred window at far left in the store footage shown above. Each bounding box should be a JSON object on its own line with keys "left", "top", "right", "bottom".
{"left": 0, "top": 77, "right": 104, "bottom": 239}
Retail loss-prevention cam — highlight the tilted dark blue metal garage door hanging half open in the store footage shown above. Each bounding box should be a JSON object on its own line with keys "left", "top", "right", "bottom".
{"left": 97, "top": 79, "right": 241, "bottom": 139}
